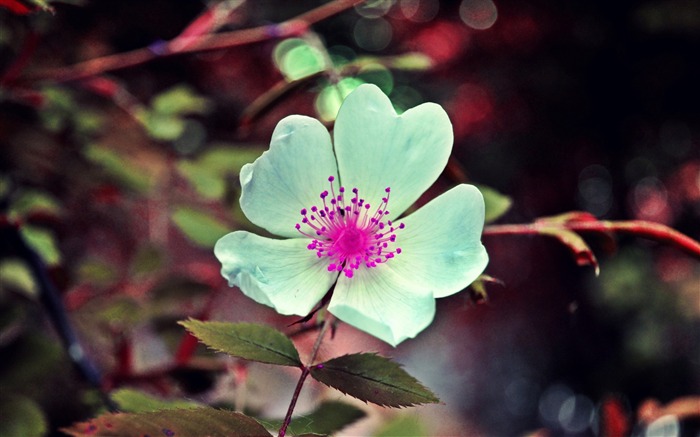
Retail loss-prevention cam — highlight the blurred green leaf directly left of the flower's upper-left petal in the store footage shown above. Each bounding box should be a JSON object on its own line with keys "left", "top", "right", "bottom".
{"left": 177, "top": 145, "right": 262, "bottom": 199}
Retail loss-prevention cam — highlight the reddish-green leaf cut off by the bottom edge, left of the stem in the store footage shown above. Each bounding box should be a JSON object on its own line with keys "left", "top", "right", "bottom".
{"left": 61, "top": 407, "right": 270, "bottom": 437}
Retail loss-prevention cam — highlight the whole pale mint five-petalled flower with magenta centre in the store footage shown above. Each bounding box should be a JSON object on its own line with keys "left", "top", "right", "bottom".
{"left": 214, "top": 85, "right": 488, "bottom": 346}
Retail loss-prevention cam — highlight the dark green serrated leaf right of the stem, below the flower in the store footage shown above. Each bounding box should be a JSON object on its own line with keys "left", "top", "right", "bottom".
{"left": 311, "top": 353, "right": 440, "bottom": 407}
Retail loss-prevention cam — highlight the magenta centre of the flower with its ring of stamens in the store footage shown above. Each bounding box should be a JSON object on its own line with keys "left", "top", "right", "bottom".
{"left": 295, "top": 176, "right": 405, "bottom": 278}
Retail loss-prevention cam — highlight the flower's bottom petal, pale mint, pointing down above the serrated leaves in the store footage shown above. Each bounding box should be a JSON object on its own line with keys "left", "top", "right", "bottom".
{"left": 328, "top": 265, "right": 435, "bottom": 346}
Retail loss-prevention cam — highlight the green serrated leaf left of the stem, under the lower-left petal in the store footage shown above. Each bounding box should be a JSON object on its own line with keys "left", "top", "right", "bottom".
{"left": 179, "top": 319, "right": 301, "bottom": 367}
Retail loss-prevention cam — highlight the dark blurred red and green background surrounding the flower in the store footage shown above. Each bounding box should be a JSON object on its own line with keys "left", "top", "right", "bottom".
{"left": 0, "top": 0, "right": 700, "bottom": 436}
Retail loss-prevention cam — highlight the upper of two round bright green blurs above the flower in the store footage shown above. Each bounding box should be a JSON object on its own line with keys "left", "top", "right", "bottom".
{"left": 272, "top": 38, "right": 326, "bottom": 82}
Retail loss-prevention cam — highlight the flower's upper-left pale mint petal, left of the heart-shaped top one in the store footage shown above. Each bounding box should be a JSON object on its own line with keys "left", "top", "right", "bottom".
{"left": 241, "top": 115, "right": 338, "bottom": 237}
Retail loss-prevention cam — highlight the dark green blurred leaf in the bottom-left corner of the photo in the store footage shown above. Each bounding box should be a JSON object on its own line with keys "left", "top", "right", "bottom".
{"left": 0, "top": 392, "right": 48, "bottom": 437}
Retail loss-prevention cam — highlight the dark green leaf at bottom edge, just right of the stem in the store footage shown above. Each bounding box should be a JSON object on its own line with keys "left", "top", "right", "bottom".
{"left": 265, "top": 401, "right": 366, "bottom": 436}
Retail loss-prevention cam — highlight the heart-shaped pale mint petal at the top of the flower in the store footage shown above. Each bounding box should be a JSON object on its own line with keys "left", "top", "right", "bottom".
{"left": 333, "top": 85, "right": 453, "bottom": 217}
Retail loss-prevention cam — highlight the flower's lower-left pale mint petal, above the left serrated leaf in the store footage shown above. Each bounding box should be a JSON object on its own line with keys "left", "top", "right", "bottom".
{"left": 214, "top": 231, "right": 336, "bottom": 316}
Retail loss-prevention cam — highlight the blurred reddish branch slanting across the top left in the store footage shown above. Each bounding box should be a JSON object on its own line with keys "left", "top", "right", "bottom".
{"left": 26, "top": 0, "right": 366, "bottom": 82}
